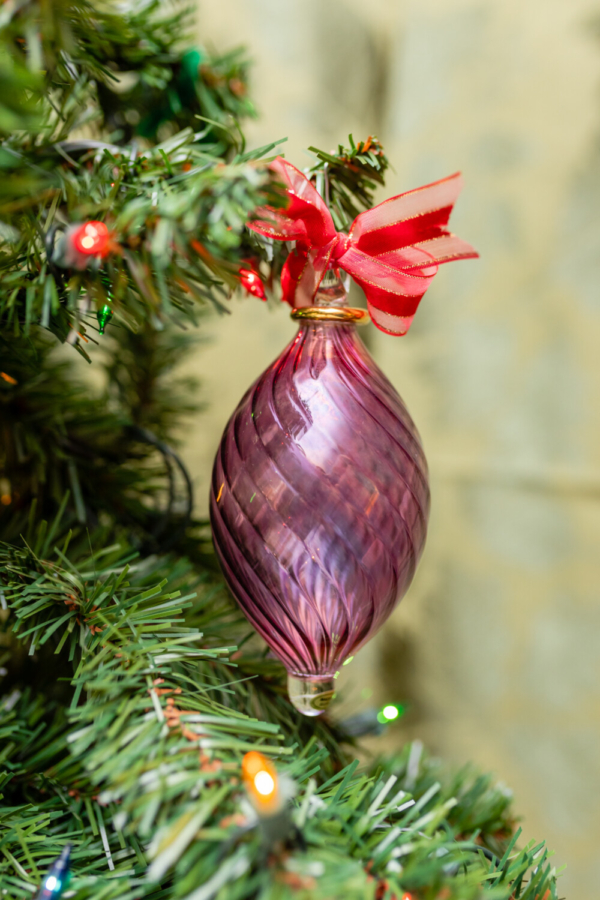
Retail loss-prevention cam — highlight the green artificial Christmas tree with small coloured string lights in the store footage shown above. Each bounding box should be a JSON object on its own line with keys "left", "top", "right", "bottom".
{"left": 0, "top": 0, "right": 557, "bottom": 900}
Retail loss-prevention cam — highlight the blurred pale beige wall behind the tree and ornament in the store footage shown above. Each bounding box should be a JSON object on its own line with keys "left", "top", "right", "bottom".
{"left": 185, "top": 0, "right": 600, "bottom": 900}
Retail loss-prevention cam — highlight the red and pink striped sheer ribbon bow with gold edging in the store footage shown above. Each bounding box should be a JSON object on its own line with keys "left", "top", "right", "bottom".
{"left": 249, "top": 156, "right": 478, "bottom": 335}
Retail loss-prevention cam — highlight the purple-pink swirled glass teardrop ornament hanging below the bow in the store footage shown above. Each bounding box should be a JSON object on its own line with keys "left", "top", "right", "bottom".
{"left": 210, "top": 278, "right": 429, "bottom": 716}
